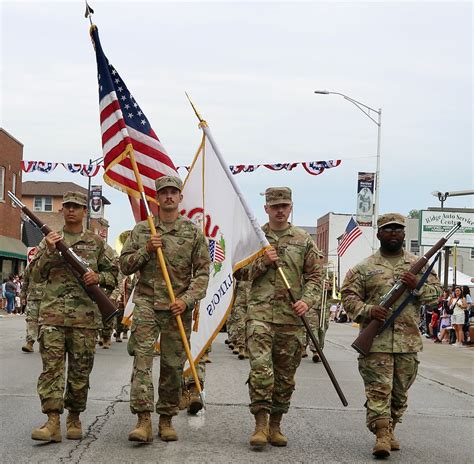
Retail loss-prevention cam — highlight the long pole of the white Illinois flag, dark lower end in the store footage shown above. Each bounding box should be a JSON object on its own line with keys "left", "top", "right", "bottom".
{"left": 186, "top": 93, "right": 348, "bottom": 406}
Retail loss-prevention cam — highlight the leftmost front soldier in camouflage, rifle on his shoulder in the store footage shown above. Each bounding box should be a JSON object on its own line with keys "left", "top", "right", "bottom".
{"left": 31, "top": 192, "right": 118, "bottom": 442}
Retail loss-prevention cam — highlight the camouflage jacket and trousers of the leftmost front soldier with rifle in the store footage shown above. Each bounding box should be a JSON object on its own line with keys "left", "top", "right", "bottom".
{"left": 32, "top": 225, "right": 118, "bottom": 413}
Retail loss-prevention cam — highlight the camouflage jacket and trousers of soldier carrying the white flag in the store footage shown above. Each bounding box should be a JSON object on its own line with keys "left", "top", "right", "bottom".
{"left": 246, "top": 224, "right": 322, "bottom": 414}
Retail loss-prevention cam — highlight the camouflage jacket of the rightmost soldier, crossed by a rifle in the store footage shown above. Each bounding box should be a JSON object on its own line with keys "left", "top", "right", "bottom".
{"left": 341, "top": 251, "right": 441, "bottom": 353}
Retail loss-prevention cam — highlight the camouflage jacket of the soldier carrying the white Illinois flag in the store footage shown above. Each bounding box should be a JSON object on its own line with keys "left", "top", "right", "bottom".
{"left": 247, "top": 224, "right": 322, "bottom": 325}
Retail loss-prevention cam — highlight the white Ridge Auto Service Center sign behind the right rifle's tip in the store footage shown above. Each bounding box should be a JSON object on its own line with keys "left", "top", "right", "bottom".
{"left": 419, "top": 210, "right": 474, "bottom": 248}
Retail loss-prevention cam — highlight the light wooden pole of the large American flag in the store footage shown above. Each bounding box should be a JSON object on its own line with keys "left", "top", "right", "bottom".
{"left": 127, "top": 145, "right": 206, "bottom": 409}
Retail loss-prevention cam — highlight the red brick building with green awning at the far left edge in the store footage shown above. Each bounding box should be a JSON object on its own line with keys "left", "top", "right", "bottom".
{"left": 0, "top": 128, "right": 26, "bottom": 279}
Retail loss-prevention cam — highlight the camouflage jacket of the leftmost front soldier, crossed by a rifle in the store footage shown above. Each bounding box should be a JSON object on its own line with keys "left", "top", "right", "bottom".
{"left": 31, "top": 230, "right": 118, "bottom": 329}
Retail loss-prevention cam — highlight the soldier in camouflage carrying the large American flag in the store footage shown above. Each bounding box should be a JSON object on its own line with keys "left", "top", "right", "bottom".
{"left": 120, "top": 176, "right": 210, "bottom": 442}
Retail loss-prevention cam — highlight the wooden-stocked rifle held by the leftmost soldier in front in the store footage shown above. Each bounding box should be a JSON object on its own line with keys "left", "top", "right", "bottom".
{"left": 8, "top": 192, "right": 118, "bottom": 323}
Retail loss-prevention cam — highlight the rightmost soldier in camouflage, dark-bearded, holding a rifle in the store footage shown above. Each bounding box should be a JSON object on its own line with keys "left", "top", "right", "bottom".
{"left": 342, "top": 213, "right": 441, "bottom": 457}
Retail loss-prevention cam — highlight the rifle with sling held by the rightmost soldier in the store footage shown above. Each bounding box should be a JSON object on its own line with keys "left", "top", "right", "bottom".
{"left": 351, "top": 222, "right": 461, "bottom": 356}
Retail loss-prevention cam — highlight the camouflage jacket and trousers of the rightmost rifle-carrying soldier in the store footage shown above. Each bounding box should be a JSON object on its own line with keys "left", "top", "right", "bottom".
{"left": 341, "top": 251, "right": 441, "bottom": 432}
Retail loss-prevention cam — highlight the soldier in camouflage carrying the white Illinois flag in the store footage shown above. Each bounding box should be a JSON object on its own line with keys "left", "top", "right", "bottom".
{"left": 246, "top": 187, "right": 321, "bottom": 447}
